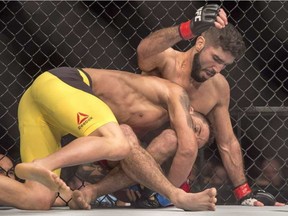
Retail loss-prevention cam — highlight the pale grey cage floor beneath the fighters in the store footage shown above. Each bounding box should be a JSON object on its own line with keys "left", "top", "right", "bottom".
{"left": 0, "top": 205, "right": 288, "bottom": 216}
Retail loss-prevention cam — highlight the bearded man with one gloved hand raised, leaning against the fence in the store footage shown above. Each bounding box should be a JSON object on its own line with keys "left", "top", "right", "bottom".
{"left": 137, "top": 4, "right": 283, "bottom": 206}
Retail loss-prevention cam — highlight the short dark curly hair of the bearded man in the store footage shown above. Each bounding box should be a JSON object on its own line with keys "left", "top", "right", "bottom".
{"left": 202, "top": 23, "right": 246, "bottom": 59}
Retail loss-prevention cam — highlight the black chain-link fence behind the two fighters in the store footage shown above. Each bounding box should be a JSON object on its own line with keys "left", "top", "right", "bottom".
{"left": 0, "top": 0, "right": 288, "bottom": 204}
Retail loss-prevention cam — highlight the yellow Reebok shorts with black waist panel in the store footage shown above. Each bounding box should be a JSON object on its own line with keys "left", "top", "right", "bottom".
{"left": 18, "top": 67, "right": 117, "bottom": 174}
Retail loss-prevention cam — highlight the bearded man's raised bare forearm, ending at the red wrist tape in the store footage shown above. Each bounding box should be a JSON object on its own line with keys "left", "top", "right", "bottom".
{"left": 137, "top": 26, "right": 182, "bottom": 59}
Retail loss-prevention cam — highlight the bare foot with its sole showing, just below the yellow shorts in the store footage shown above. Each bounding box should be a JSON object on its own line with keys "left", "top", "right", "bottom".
{"left": 15, "top": 162, "right": 70, "bottom": 192}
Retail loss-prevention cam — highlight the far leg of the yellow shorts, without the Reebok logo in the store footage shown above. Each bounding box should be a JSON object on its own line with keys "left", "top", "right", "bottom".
{"left": 18, "top": 89, "right": 61, "bottom": 174}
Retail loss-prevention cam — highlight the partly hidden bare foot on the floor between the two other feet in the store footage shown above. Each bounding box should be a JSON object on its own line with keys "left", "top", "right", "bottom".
{"left": 68, "top": 190, "right": 91, "bottom": 210}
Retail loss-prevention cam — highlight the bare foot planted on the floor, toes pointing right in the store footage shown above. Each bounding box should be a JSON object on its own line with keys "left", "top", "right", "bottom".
{"left": 173, "top": 188, "right": 217, "bottom": 211}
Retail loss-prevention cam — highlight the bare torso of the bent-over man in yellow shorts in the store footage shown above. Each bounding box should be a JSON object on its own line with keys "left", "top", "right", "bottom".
{"left": 83, "top": 68, "right": 171, "bottom": 136}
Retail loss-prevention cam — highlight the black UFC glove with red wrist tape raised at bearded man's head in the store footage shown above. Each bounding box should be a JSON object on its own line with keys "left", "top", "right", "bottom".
{"left": 179, "top": 4, "right": 220, "bottom": 40}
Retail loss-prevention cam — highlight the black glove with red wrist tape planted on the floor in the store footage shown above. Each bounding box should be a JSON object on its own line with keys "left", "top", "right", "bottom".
{"left": 234, "top": 183, "right": 276, "bottom": 206}
